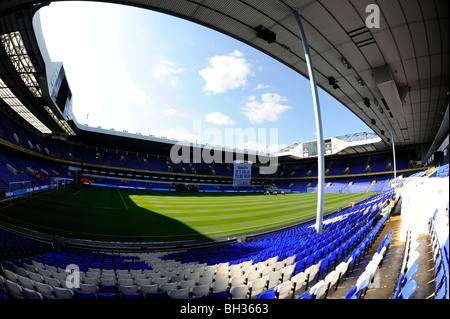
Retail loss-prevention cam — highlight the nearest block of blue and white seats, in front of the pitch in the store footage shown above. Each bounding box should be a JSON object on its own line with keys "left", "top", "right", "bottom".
{"left": 1, "top": 188, "right": 392, "bottom": 299}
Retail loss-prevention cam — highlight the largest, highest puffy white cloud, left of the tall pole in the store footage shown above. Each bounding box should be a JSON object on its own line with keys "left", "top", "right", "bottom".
{"left": 199, "top": 50, "right": 252, "bottom": 94}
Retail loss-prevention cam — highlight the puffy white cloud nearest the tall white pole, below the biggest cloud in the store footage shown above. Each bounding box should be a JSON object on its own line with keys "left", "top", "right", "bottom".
{"left": 242, "top": 93, "right": 292, "bottom": 124}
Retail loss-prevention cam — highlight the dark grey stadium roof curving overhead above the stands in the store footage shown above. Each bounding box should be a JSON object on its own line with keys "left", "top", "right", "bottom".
{"left": 0, "top": 0, "right": 449, "bottom": 159}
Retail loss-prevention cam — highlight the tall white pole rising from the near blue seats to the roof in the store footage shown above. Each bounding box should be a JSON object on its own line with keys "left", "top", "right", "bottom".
{"left": 292, "top": 9, "right": 325, "bottom": 234}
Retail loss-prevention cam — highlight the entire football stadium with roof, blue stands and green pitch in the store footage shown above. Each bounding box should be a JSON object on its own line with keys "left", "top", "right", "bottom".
{"left": 0, "top": 0, "right": 449, "bottom": 310}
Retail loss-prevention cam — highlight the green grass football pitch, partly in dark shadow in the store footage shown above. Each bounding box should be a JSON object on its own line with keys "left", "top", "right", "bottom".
{"left": 0, "top": 185, "right": 373, "bottom": 242}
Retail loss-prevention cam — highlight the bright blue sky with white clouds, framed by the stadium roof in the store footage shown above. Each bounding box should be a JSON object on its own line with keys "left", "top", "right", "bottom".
{"left": 40, "top": 2, "right": 371, "bottom": 151}
